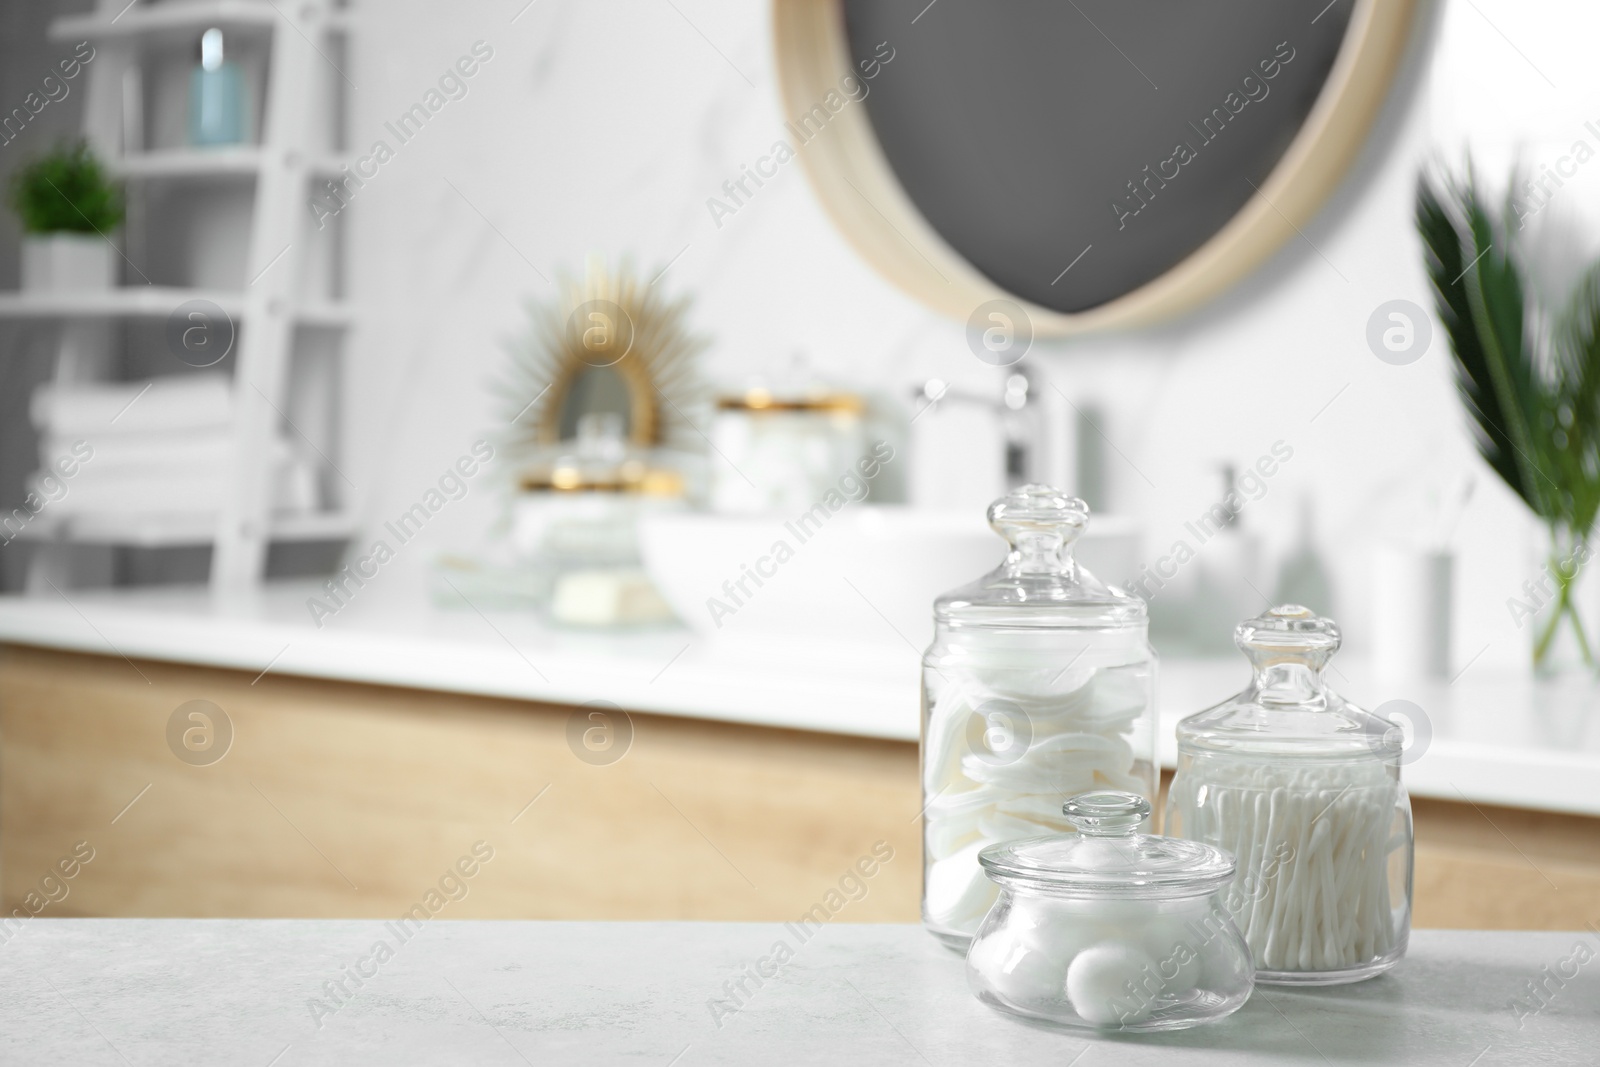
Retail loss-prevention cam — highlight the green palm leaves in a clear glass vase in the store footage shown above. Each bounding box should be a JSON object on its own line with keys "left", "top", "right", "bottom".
{"left": 1416, "top": 165, "right": 1600, "bottom": 675}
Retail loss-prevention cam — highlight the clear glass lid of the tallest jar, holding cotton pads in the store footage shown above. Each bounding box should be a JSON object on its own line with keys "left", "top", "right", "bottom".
{"left": 933, "top": 485, "right": 1146, "bottom": 629}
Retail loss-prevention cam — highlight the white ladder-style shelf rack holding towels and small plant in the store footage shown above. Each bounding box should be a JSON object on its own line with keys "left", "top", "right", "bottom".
{"left": 15, "top": 0, "right": 357, "bottom": 592}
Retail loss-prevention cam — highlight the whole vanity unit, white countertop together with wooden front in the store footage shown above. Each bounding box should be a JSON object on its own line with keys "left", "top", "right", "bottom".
{"left": 0, "top": 576, "right": 1600, "bottom": 929}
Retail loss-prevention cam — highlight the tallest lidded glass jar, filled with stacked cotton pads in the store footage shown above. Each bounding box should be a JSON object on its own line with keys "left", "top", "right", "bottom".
{"left": 922, "top": 485, "right": 1157, "bottom": 952}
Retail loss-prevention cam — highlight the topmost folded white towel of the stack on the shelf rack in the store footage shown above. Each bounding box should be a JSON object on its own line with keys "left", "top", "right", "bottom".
{"left": 29, "top": 374, "right": 234, "bottom": 440}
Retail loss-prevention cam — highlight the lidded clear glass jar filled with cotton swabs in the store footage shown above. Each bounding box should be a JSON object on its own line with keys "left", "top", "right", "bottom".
{"left": 1166, "top": 605, "right": 1413, "bottom": 985}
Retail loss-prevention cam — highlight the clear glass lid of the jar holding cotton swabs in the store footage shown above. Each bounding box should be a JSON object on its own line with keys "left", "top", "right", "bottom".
{"left": 1178, "top": 605, "right": 1405, "bottom": 760}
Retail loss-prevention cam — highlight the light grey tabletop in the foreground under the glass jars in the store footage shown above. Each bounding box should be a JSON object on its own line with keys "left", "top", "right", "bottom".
{"left": 0, "top": 920, "right": 1600, "bottom": 1067}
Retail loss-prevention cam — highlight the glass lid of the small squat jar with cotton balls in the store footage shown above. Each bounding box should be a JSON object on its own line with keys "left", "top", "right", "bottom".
{"left": 978, "top": 789, "right": 1234, "bottom": 899}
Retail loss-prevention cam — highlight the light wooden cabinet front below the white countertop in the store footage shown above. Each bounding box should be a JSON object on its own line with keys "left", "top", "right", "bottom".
{"left": 0, "top": 646, "right": 1600, "bottom": 929}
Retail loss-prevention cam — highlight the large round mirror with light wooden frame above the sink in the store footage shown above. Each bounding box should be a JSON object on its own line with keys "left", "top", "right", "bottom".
{"left": 774, "top": 0, "right": 1416, "bottom": 334}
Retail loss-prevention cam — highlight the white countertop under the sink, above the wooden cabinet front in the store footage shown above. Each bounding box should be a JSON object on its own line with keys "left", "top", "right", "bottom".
{"left": 0, "top": 585, "right": 1600, "bottom": 816}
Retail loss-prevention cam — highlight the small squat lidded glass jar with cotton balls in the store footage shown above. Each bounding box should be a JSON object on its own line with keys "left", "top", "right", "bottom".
{"left": 966, "top": 790, "right": 1254, "bottom": 1030}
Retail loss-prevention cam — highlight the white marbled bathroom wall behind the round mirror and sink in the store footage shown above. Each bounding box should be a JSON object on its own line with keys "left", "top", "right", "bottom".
{"left": 0, "top": 3, "right": 1574, "bottom": 665}
